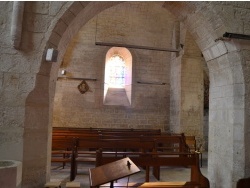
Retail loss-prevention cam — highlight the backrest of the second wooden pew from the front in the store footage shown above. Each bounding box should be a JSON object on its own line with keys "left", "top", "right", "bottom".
{"left": 73, "top": 136, "right": 187, "bottom": 169}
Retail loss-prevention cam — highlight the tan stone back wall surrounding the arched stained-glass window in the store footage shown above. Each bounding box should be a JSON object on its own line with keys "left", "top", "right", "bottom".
{"left": 53, "top": 2, "right": 175, "bottom": 131}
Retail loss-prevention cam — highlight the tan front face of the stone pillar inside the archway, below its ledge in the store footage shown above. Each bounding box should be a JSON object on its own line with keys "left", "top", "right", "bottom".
{"left": 180, "top": 55, "right": 204, "bottom": 145}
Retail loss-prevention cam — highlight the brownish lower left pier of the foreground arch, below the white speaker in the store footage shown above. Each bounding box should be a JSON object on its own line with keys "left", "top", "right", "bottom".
{"left": 22, "top": 74, "right": 52, "bottom": 188}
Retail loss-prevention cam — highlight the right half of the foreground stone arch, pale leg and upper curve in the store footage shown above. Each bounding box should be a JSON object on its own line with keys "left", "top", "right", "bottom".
{"left": 164, "top": 2, "right": 249, "bottom": 188}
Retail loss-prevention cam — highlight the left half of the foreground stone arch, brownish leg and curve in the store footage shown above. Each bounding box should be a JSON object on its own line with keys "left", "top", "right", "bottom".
{"left": 22, "top": 2, "right": 122, "bottom": 188}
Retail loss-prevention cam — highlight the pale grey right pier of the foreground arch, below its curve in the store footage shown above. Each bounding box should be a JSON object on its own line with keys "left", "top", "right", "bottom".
{"left": 205, "top": 50, "right": 245, "bottom": 188}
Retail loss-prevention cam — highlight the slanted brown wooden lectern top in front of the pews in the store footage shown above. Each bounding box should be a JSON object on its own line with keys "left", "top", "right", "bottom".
{"left": 89, "top": 157, "right": 140, "bottom": 187}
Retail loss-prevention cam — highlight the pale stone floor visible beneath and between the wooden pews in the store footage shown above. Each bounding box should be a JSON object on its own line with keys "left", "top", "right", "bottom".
{"left": 51, "top": 152, "right": 207, "bottom": 188}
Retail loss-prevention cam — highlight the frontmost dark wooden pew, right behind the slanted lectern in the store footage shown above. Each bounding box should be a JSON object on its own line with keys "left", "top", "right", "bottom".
{"left": 94, "top": 150, "right": 209, "bottom": 188}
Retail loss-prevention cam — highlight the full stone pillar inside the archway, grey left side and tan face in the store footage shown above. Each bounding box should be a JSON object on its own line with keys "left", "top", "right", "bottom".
{"left": 170, "top": 24, "right": 204, "bottom": 143}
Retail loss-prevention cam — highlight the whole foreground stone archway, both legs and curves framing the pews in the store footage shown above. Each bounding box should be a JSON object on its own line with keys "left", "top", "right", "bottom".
{"left": 23, "top": 2, "right": 250, "bottom": 188}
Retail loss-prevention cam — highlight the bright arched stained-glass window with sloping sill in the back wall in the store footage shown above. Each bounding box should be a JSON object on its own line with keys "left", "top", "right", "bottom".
{"left": 103, "top": 47, "right": 132, "bottom": 106}
